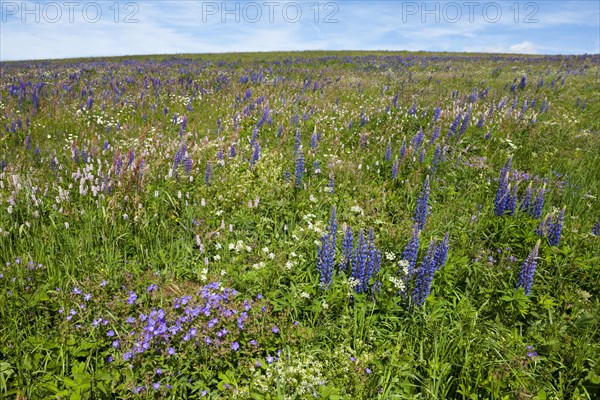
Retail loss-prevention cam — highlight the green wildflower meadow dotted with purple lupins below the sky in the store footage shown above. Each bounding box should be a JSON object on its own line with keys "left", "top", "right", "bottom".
{"left": 0, "top": 52, "right": 600, "bottom": 400}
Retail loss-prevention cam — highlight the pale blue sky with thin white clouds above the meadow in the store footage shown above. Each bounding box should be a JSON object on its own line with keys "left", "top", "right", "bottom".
{"left": 0, "top": 0, "right": 600, "bottom": 61}
